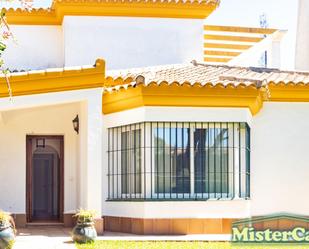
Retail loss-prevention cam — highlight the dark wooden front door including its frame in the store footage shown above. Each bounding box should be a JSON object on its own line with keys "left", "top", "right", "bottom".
{"left": 26, "top": 135, "right": 64, "bottom": 222}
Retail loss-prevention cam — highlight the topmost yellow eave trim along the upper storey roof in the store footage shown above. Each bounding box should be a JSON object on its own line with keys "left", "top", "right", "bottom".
{"left": 6, "top": 0, "right": 218, "bottom": 25}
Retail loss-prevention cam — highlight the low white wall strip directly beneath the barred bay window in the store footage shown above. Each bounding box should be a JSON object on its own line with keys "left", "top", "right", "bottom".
{"left": 103, "top": 200, "right": 250, "bottom": 218}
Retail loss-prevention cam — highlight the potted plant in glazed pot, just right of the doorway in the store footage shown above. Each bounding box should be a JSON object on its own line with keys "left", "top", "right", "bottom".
{"left": 72, "top": 209, "right": 97, "bottom": 243}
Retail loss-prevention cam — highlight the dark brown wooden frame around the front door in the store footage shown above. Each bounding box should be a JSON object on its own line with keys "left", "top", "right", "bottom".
{"left": 26, "top": 135, "right": 64, "bottom": 222}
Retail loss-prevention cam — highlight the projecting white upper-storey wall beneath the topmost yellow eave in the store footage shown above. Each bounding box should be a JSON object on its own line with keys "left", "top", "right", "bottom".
{"left": 63, "top": 16, "right": 203, "bottom": 69}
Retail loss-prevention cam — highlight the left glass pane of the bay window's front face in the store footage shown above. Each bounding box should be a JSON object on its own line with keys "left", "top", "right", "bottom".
{"left": 153, "top": 127, "right": 190, "bottom": 194}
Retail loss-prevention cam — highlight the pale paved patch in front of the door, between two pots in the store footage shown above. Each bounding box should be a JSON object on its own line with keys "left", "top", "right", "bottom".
{"left": 13, "top": 227, "right": 76, "bottom": 249}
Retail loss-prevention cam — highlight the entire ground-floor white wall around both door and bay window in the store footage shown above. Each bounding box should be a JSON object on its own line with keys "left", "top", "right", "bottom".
{"left": 0, "top": 94, "right": 309, "bottom": 218}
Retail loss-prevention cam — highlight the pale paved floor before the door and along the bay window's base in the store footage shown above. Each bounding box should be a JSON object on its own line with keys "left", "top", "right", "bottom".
{"left": 13, "top": 227, "right": 231, "bottom": 249}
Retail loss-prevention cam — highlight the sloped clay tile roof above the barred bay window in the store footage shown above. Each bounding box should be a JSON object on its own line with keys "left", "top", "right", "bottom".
{"left": 106, "top": 61, "right": 309, "bottom": 90}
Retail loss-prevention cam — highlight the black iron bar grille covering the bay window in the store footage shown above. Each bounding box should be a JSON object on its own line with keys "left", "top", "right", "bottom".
{"left": 108, "top": 122, "right": 250, "bottom": 200}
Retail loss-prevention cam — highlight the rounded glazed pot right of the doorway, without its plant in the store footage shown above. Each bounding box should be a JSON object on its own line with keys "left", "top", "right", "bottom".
{"left": 72, "top": 222, "right": 97, "bottom": 243}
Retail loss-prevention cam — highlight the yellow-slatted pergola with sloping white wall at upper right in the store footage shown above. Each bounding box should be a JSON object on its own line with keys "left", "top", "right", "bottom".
{"left": 204, "top": 25, "right": 286, "bottom": 68}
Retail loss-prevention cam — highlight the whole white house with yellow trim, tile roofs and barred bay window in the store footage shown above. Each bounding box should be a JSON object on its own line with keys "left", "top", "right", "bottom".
{"left": 0, "top": 0, "right": 309, "bottom": 234}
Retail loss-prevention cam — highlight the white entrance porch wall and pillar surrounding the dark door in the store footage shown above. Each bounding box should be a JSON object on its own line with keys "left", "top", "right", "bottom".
{"left": 0, "top": 88, "right": 102, "bottom": 215}
